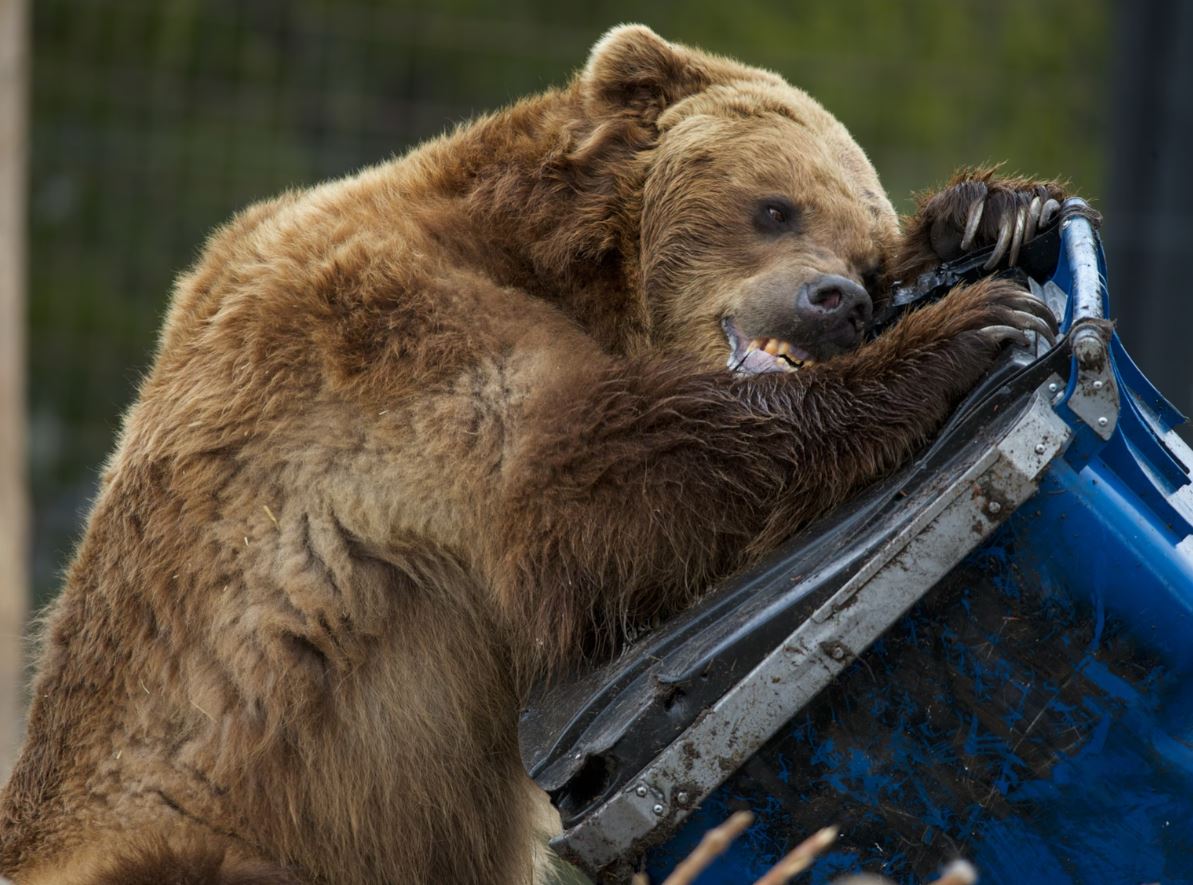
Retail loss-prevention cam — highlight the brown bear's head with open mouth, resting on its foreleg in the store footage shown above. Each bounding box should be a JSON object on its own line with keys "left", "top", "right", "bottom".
{"left": 579, "top": 25, "right": 898, "bottom": 373}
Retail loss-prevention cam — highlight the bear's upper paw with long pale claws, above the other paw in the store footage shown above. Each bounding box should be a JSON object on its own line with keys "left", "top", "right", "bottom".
{"left": 921, "top": 175, "right": 1068, "bottom": 271}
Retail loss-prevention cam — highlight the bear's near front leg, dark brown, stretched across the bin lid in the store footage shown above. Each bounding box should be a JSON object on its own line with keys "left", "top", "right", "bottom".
{"left": 484, "top": 279, "right": 1055, "bottom": 670}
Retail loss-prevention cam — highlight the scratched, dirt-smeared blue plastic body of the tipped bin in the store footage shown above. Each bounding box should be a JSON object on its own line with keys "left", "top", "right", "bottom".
{"left": 647, "top": 225, "right": 1193, "bottom": 885}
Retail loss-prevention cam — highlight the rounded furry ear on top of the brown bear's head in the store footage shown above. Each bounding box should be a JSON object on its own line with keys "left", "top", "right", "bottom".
{"left": 580, "top": 25, "right": 710, "bottom": 123}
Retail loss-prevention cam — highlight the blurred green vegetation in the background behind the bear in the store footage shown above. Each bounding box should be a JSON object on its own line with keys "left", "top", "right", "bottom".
{"left": 29, "top": 0, "right": 1109, "bottom": 602}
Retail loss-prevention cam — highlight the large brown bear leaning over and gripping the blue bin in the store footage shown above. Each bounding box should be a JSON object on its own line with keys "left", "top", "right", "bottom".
{"left": 0, "top": 26, "right": 1063, "bottom": 885}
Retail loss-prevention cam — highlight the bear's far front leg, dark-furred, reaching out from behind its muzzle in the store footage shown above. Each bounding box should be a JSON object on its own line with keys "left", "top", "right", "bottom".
{"left": 894, "top": 169, "right": 1100, "bottom": 281}
